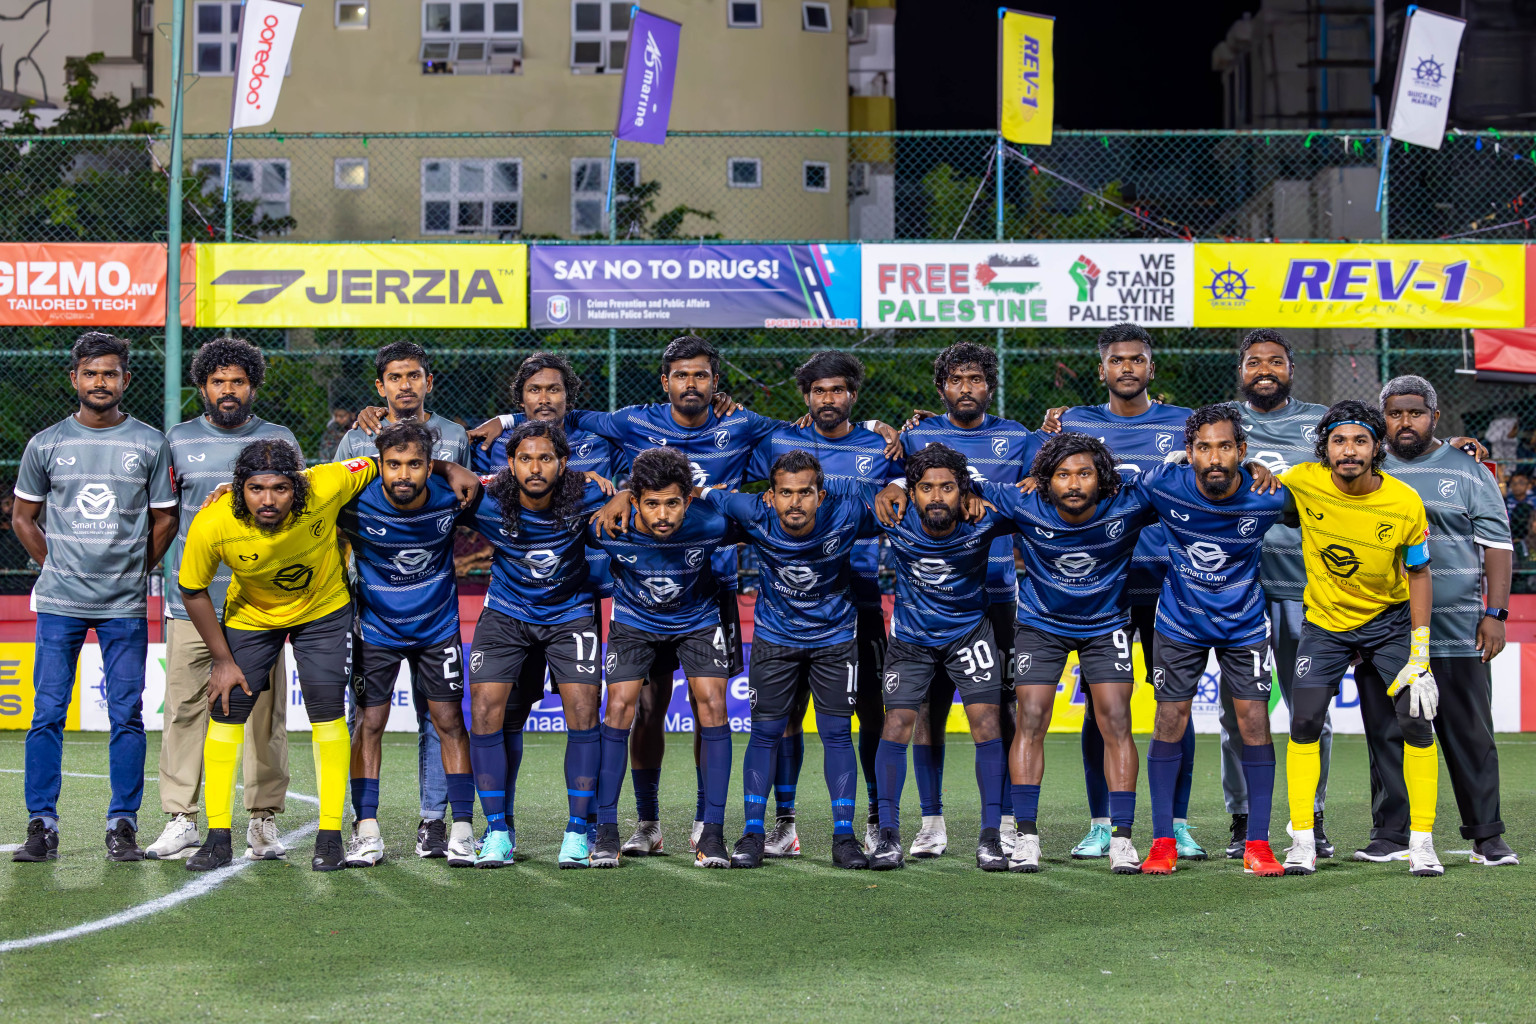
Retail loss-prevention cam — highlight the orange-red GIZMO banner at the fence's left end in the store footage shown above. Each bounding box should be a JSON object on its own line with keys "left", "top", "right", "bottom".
{"left": 0, "top": 243, "right": 197, "bottom": 327}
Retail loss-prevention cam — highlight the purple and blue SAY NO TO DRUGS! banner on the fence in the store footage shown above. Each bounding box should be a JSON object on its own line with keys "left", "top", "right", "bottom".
{"left": 528, "top": 244, "right": 859, "bottom": 327}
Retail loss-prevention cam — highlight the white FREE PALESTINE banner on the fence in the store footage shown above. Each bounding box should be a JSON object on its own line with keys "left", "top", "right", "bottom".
{"left": 862, "top": 241, "right": 1195, "bottom": 329}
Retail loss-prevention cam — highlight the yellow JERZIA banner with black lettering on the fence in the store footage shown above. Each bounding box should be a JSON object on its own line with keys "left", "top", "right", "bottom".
{"left": 197, "top": 243, "right": 528, "bottom": 327}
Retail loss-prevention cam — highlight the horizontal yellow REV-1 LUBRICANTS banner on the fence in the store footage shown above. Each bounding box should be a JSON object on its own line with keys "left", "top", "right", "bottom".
{"left": 1195, "top": 243, "right": 1525, "bottom": 329}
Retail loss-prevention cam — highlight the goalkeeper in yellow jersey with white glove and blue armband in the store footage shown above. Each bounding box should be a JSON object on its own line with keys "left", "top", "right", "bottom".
{"left": 1279, "top": 401, "right": 1445, "bottom": 875}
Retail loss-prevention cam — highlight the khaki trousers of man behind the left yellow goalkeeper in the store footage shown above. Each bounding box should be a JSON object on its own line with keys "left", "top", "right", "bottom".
{"left": 160, "top": 619, "right": 289, "bottom": 817}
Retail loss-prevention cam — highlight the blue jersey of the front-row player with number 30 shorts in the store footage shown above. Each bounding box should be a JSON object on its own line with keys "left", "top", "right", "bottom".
{"left": 885, "top": 500, "right": 1014, "bottom": 646}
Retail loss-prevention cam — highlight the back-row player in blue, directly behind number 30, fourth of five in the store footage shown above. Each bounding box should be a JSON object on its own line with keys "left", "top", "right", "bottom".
{"left": 902, "top": 348, "right": 1041, "bottom": 857}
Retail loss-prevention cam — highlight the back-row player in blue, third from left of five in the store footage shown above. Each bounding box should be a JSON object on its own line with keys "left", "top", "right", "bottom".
{"left": 746, "top": 352, "right": 905, "bottom": 857}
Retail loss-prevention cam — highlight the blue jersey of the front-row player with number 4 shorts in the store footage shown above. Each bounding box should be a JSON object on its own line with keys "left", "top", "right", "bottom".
{"left": 587, "top": 497, "right": 740, "bottom": 636}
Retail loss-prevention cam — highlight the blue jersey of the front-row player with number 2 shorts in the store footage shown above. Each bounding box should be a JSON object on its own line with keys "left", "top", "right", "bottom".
{"left": 336, "top": 476, "right": 459, "bottom": 651}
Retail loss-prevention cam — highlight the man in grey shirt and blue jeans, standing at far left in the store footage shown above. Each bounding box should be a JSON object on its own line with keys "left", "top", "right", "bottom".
{"left": 12, "top": 332, "right": 177, "bottom": 861}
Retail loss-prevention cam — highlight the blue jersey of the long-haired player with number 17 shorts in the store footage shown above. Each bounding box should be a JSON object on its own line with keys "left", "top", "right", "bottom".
{"left": 475, "top": 484, "right": 608, "bottom": 626}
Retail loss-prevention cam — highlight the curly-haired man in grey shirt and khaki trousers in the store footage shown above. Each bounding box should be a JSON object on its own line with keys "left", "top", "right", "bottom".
{"left": 144, "top": 338, "right": 298, "bottom": 860}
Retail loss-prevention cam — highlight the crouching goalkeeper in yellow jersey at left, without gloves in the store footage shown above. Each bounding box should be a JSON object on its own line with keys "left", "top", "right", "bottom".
{"left": 180, "top": 438, "right": 479, "bottom": 870}
